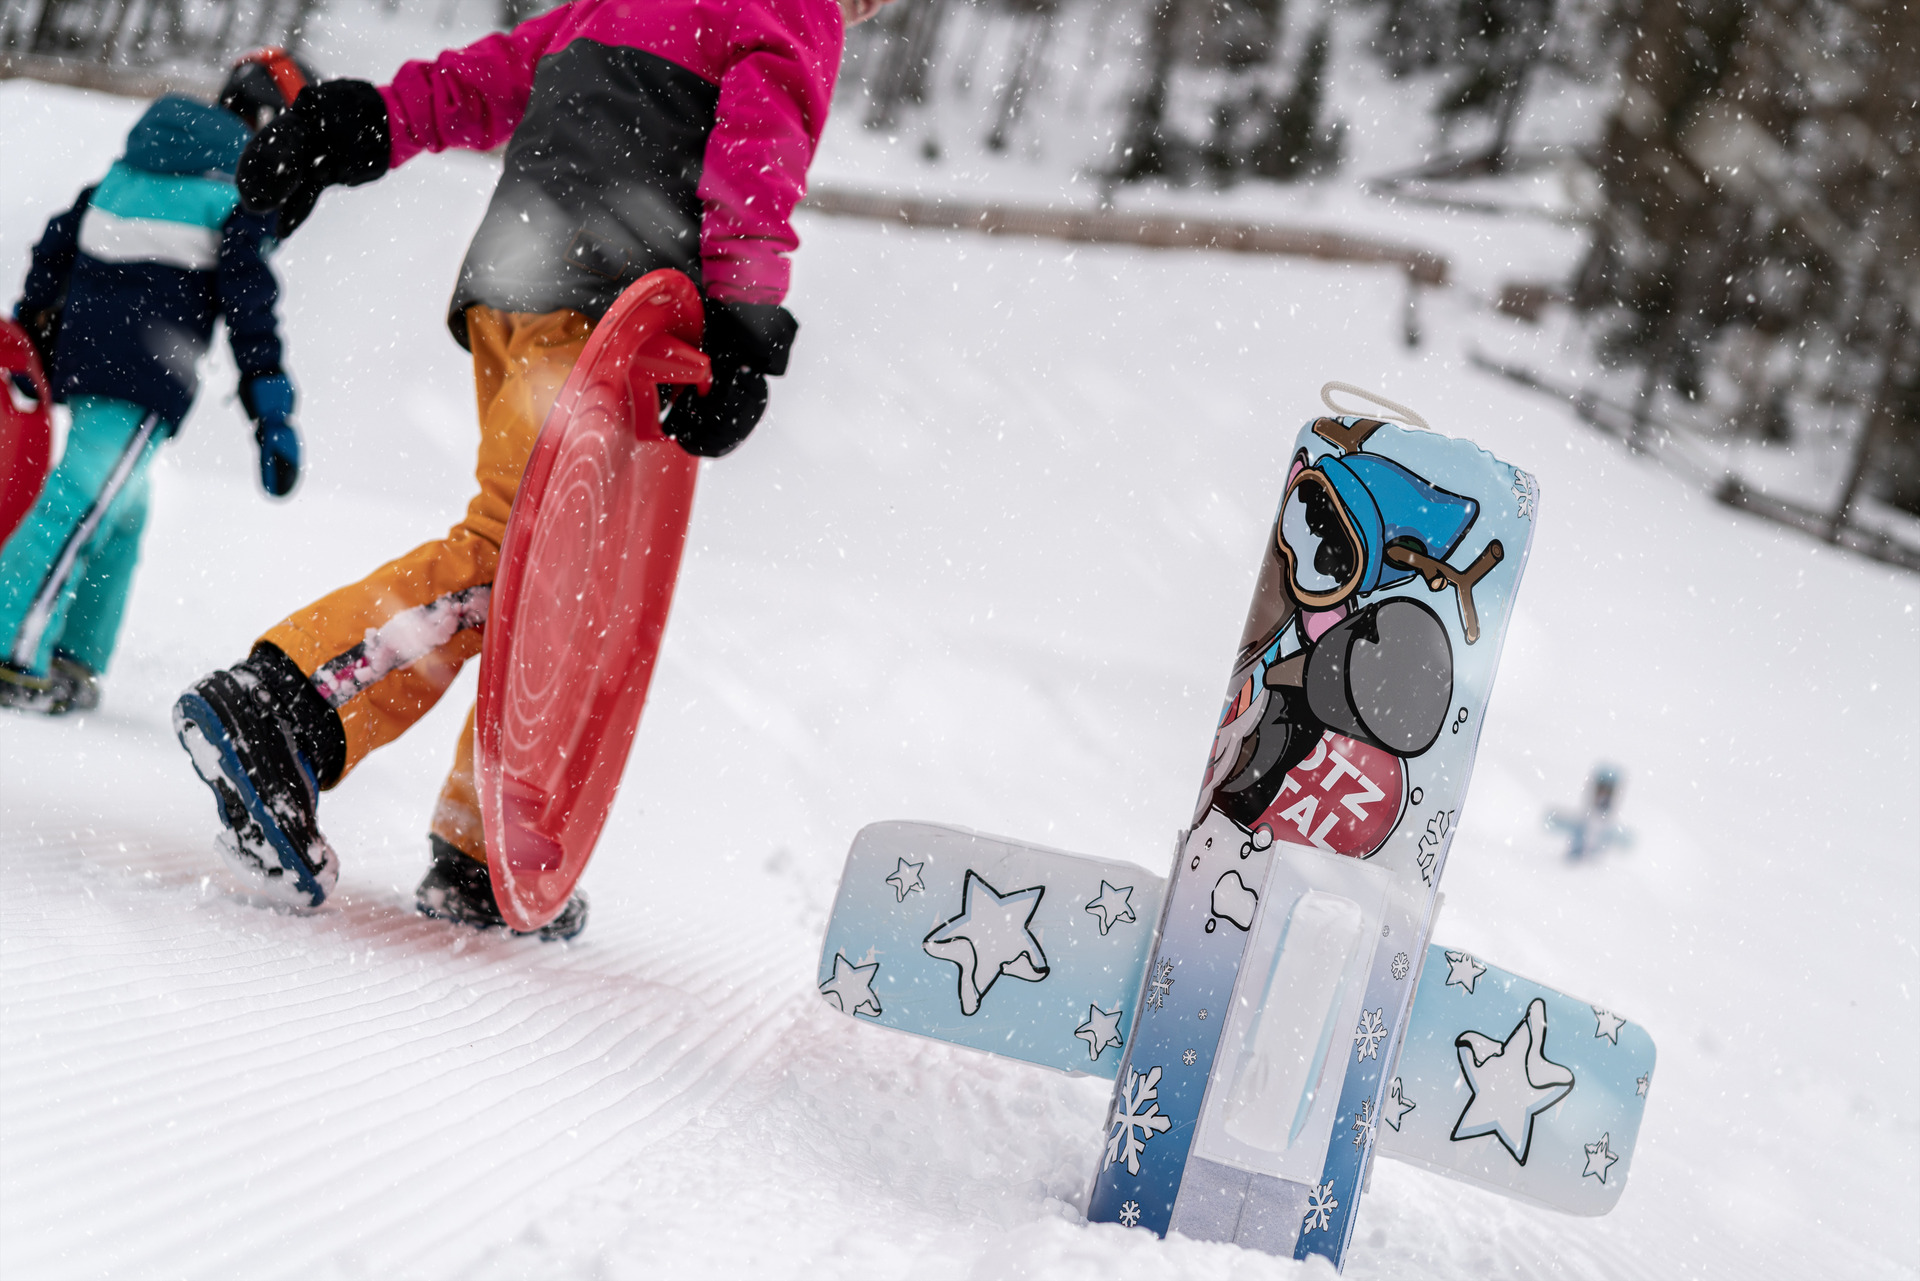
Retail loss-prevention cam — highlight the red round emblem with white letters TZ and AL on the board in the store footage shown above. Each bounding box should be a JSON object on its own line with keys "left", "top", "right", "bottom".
{"left": 1254, "top": 730, "right": 1407, "bottom": 858}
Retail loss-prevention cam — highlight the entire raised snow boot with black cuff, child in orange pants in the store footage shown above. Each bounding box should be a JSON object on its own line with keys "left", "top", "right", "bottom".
{"left": 173, "top": 645, "right": 346, "bottom": 906}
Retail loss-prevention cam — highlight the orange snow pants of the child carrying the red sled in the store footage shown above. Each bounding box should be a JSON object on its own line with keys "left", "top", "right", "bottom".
{"left": 261, "top": 305, "right": 593, "bottom": 862}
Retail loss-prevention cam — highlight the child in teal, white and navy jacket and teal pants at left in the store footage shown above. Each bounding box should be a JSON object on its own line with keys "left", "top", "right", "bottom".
{"left": 0, "top": 50, "right": 305, "bottom": 714}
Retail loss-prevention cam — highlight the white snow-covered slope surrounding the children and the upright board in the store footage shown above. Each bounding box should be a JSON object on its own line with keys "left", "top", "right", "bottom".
{"left": 0, "top": 81, "right": 1920, "bottom": 1277}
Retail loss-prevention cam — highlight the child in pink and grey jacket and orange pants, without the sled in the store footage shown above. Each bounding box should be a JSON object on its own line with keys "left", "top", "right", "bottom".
{"left": 175, "top": 0, "right": 885, "bottom": 939}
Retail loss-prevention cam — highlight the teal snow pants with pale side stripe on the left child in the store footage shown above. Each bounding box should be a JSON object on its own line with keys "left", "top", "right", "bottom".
{"left": 0, "top": 396, "right": 165, "bottom": 676}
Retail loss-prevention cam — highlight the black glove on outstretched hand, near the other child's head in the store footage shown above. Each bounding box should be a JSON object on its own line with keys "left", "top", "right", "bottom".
{"left": 234, "top": 81, "right": 394, "bottom": 240}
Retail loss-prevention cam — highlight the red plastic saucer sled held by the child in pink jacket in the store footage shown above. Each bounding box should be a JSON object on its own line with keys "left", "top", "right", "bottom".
{"left": 474, "top": 271, "right": 712, "bottom": 930}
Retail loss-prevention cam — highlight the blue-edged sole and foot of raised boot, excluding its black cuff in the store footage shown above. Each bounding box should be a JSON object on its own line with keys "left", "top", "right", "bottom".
{"left": 173, "top": 666, "right": 340, "bottom": 908}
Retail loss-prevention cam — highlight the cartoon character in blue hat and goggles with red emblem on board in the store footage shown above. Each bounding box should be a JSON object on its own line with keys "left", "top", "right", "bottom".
{"left": 1194, "top": 419, "right": 1505, "bottom": 857}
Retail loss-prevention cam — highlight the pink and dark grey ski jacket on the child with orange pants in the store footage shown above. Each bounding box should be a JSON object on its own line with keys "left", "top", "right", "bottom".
{"left": 380, "top": 0, "right": 845, "bottom": 346}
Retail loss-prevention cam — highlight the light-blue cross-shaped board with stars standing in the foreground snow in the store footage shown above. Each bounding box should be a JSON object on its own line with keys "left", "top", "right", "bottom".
{"left": 820, "top": 388, "right": 1655, "bottom": 1266}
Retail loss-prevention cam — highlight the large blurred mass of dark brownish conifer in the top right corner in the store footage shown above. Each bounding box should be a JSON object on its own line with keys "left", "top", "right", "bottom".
{"left": 1574, "top": 0, "right": 1920, "bottom": 515}
